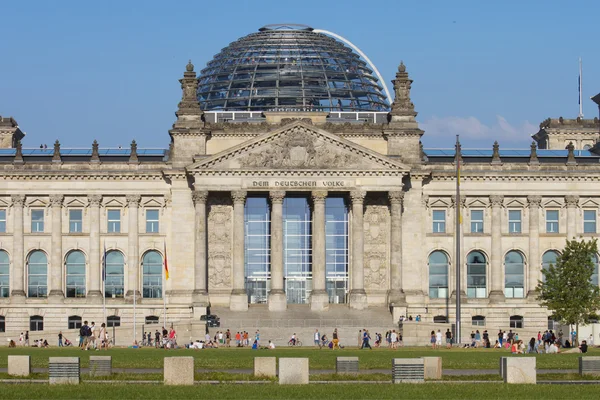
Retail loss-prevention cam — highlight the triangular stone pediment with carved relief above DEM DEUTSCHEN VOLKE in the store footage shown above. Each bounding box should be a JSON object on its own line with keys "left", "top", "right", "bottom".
{"left": 188, "top": 121, "right": 409, "bottom": 172}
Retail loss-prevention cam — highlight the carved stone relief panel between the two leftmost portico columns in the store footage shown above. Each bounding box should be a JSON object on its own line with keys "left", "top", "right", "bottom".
{"left": 208, "top": 194, "right": 233, "bottom": 290}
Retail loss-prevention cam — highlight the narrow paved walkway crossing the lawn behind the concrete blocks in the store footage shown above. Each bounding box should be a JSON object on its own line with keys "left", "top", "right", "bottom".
{"left": 0, "top": 368, "right": 579, "bottom": 376}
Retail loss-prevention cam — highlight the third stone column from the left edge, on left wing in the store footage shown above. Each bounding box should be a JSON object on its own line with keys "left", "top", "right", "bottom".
{"left": 87, "top": 194, "right": 102, "bottom": 302}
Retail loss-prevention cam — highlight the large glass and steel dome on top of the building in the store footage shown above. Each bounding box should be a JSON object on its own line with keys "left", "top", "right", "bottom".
{"left": 198, "top": 25, "right": 390, "bottom": 112}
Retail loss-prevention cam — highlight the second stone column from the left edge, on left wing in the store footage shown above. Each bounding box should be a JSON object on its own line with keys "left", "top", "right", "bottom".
{"left": 48, "top": 194, "right": 65, "bottom": 302}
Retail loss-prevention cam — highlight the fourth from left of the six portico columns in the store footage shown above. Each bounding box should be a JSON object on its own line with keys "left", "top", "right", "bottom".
{"left": 310, "top": 190, "right": 329, "bottom": 311}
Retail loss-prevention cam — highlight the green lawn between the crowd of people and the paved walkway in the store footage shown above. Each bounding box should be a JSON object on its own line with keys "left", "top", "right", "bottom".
{"left": 0, "top": 347, "right": 600, "bottom": 370}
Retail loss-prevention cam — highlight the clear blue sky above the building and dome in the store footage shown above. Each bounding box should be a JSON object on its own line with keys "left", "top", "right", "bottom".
{"left": 0, "top": 0, "right": 600, "bottom": 148}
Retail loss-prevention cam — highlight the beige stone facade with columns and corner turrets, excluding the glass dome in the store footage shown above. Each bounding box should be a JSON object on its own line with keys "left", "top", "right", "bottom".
{"left": 0, "top": 64, "right": 600, "bottom": 338}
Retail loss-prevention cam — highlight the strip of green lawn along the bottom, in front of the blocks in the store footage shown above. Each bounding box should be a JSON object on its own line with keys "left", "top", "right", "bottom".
{"left": 1, "top": 382, "right": 598, "bottom": 400}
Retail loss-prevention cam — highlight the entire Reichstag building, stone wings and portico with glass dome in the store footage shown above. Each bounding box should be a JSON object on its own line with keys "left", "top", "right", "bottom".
{"left": 0, "top": 25, "right": 600, "bottom": 337}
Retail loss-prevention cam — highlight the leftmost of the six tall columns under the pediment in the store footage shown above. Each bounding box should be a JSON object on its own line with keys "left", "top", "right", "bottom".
{"left": 192, "top": 190, "right": 208, "bottom": 307}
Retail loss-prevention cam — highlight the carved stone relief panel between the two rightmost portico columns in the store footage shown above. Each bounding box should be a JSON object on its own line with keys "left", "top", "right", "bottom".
{"left": 364, "top": 193, "right": 390, "bottom": 290}
